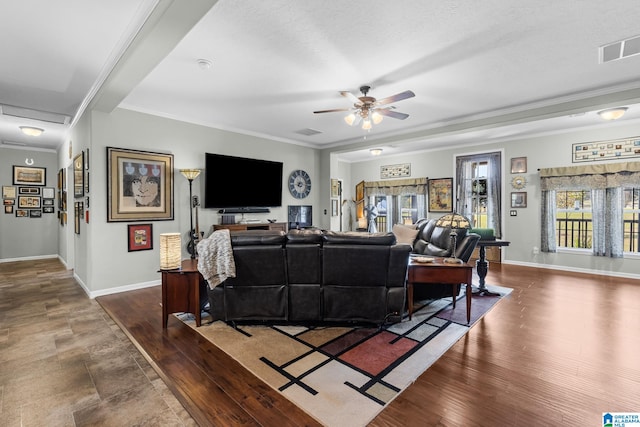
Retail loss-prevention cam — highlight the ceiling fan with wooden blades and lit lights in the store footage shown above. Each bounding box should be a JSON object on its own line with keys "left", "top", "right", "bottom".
{"left": 314, "top": 86, "right": 416, "bottom": 130}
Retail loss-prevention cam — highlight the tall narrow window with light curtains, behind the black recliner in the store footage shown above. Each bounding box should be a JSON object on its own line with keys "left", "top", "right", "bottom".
{"left": 455, "top": 152, "right": 502, "bottom": 238}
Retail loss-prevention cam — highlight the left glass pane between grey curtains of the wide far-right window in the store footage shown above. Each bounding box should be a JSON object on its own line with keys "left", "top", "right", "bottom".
{"left": 556, "top": 190, "right": 593, "bottom": 249}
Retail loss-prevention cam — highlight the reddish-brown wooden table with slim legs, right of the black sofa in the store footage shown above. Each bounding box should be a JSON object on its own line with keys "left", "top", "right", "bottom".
{"left": 407, "top": 257, "right": 473, "bottom": 323}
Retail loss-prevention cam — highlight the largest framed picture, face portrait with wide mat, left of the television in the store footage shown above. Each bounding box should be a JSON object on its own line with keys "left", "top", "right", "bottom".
{"left": 107, "top": 147, "right": 173, "bottom": 222}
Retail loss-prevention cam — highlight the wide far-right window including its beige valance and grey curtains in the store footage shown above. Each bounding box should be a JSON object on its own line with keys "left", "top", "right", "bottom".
{"left": 540, "top": 162, "right": 640, "bottom": 258}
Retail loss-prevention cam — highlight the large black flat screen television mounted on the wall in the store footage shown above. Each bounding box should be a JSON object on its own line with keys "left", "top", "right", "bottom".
{"left": 204, "top": 153, "right": 282, "bottom": 209}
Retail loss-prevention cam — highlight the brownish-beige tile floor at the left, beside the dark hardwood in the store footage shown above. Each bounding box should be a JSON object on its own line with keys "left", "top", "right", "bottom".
{"left": 0, "top": 259, "right": 196, "bottom": 427}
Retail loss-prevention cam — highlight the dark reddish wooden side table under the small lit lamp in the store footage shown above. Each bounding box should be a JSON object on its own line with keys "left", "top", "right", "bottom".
{"left": 160, "top": 259, "right": 201, "bottom": 329}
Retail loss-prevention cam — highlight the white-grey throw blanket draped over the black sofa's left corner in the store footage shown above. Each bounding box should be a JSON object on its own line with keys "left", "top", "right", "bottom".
{"left": 196, "top": 229, "right": 236, "bottom": 289}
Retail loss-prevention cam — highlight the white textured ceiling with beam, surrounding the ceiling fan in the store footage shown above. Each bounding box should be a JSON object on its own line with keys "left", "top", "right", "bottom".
{"left": 0, "top": 0, "right": 640, "bottom": 161}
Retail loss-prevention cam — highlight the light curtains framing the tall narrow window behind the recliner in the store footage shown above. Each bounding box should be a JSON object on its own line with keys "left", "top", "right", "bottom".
{"left": 456, "top": 152, "right": 502, "bottom": 238}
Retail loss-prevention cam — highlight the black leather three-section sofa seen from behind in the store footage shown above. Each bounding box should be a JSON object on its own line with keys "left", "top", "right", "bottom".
{"left": 207, "top": 230, "right": 412, "bottom": 325}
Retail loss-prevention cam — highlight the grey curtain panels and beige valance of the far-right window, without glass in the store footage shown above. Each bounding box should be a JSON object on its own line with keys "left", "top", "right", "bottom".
{"left": 540, "top": 162, "right": 640, "bottom": 254}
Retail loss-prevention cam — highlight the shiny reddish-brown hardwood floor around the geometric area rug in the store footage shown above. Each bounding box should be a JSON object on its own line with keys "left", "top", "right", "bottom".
{"left": 97, "top": 264, "right": 640, "bottom": 426}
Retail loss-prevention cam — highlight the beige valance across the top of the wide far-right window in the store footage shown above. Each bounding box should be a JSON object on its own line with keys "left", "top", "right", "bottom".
{"left": 540, "top": 162, "right": 640, "bottom": 190}
